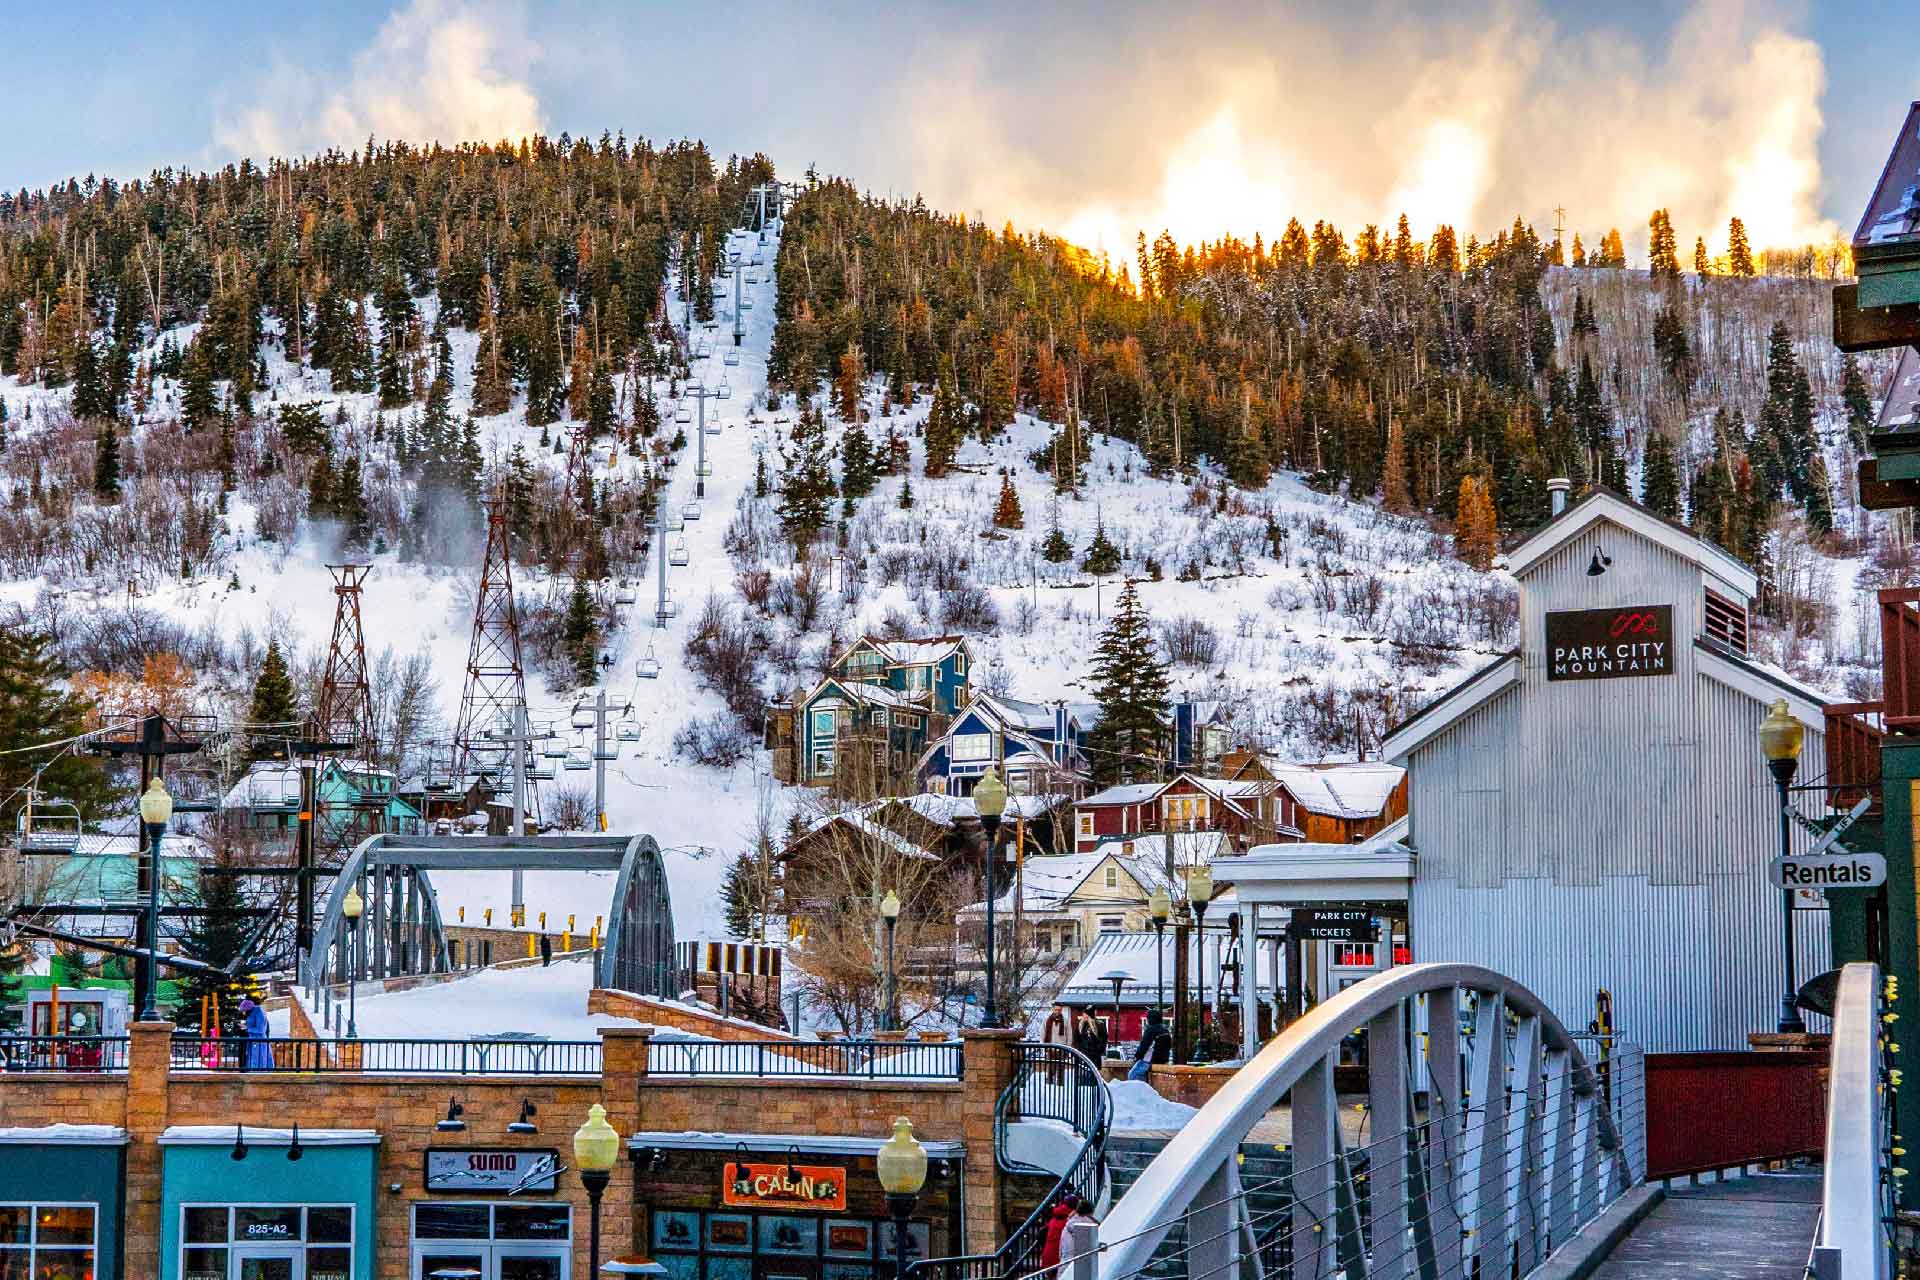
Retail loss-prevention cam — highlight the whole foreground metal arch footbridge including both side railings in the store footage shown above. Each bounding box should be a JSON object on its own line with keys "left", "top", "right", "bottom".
{"left": 1075, "top": 963, "right": 1895, "bottom": 1280}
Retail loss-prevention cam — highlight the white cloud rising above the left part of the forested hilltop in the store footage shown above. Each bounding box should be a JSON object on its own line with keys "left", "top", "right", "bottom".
{"left": 213, "top": 0, "right": 543, "bottom": 159}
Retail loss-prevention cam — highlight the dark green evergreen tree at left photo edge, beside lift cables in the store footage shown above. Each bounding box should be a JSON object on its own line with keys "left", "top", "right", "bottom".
{"left": 0, "top": 620, "right": 115, "bottom": 831}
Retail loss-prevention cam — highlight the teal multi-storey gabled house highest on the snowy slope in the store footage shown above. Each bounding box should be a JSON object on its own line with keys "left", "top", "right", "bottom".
{"left": 783, "top": 635, "right": 970, "bottom": 785}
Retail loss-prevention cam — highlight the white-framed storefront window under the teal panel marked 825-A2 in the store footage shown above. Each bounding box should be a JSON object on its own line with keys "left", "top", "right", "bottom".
{"left": 178, "top": 1205, "right": 353, "bottom": 1280}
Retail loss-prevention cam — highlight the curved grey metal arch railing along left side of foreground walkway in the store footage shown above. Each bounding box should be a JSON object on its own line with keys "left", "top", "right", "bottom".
{"left": 1098, "top": 963, "right": 1638, "bottom": 1280}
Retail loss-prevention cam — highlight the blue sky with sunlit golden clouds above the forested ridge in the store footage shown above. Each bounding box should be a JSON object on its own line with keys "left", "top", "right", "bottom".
{"left": 0, "top": 0, "right": 1920, "bottom": 251}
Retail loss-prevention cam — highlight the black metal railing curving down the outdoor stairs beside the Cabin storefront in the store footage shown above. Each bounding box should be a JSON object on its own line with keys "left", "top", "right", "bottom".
{"left": 906, "top": 1040, "right": 1112, "bottom": 1280}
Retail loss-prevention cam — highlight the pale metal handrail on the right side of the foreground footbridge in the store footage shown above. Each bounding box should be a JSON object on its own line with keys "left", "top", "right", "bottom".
{"left": 1814, "top": 963, "right": 1895, "bottom": 1280}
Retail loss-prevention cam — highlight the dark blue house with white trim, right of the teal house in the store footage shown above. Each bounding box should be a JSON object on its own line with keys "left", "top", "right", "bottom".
{"left": 914, "top": 693, "right": 1100, "bottom": 796}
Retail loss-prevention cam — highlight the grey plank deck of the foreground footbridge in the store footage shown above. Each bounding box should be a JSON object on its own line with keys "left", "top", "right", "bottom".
{"left": 1594, "top": 1167, "right": 1820, "bottom": 1280}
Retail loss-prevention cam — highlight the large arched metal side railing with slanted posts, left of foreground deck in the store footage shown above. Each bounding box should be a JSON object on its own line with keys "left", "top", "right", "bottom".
{"left": 1090, "top": 963, "right": 1645, "bottom": 1280}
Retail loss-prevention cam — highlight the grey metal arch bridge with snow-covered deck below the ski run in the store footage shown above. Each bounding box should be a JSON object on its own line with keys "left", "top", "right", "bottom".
{"left": 300, "top": 835, "right": 674, "bottom": 996}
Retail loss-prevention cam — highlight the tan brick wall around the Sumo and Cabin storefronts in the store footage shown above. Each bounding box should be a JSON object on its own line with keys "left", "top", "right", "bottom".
{"left": 0, "top": 1020, "right": 1018, "bottom": 1280}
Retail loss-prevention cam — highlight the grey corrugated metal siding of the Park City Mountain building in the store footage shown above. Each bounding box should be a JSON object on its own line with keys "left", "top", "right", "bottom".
{"left": 1407, "top": 524, "right": 1828, "bottom": 1052}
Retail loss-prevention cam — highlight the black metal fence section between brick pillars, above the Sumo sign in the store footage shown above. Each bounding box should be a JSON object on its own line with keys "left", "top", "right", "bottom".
{"left": 171, "top": 1036, "right": 601, "bottom": 1075}
